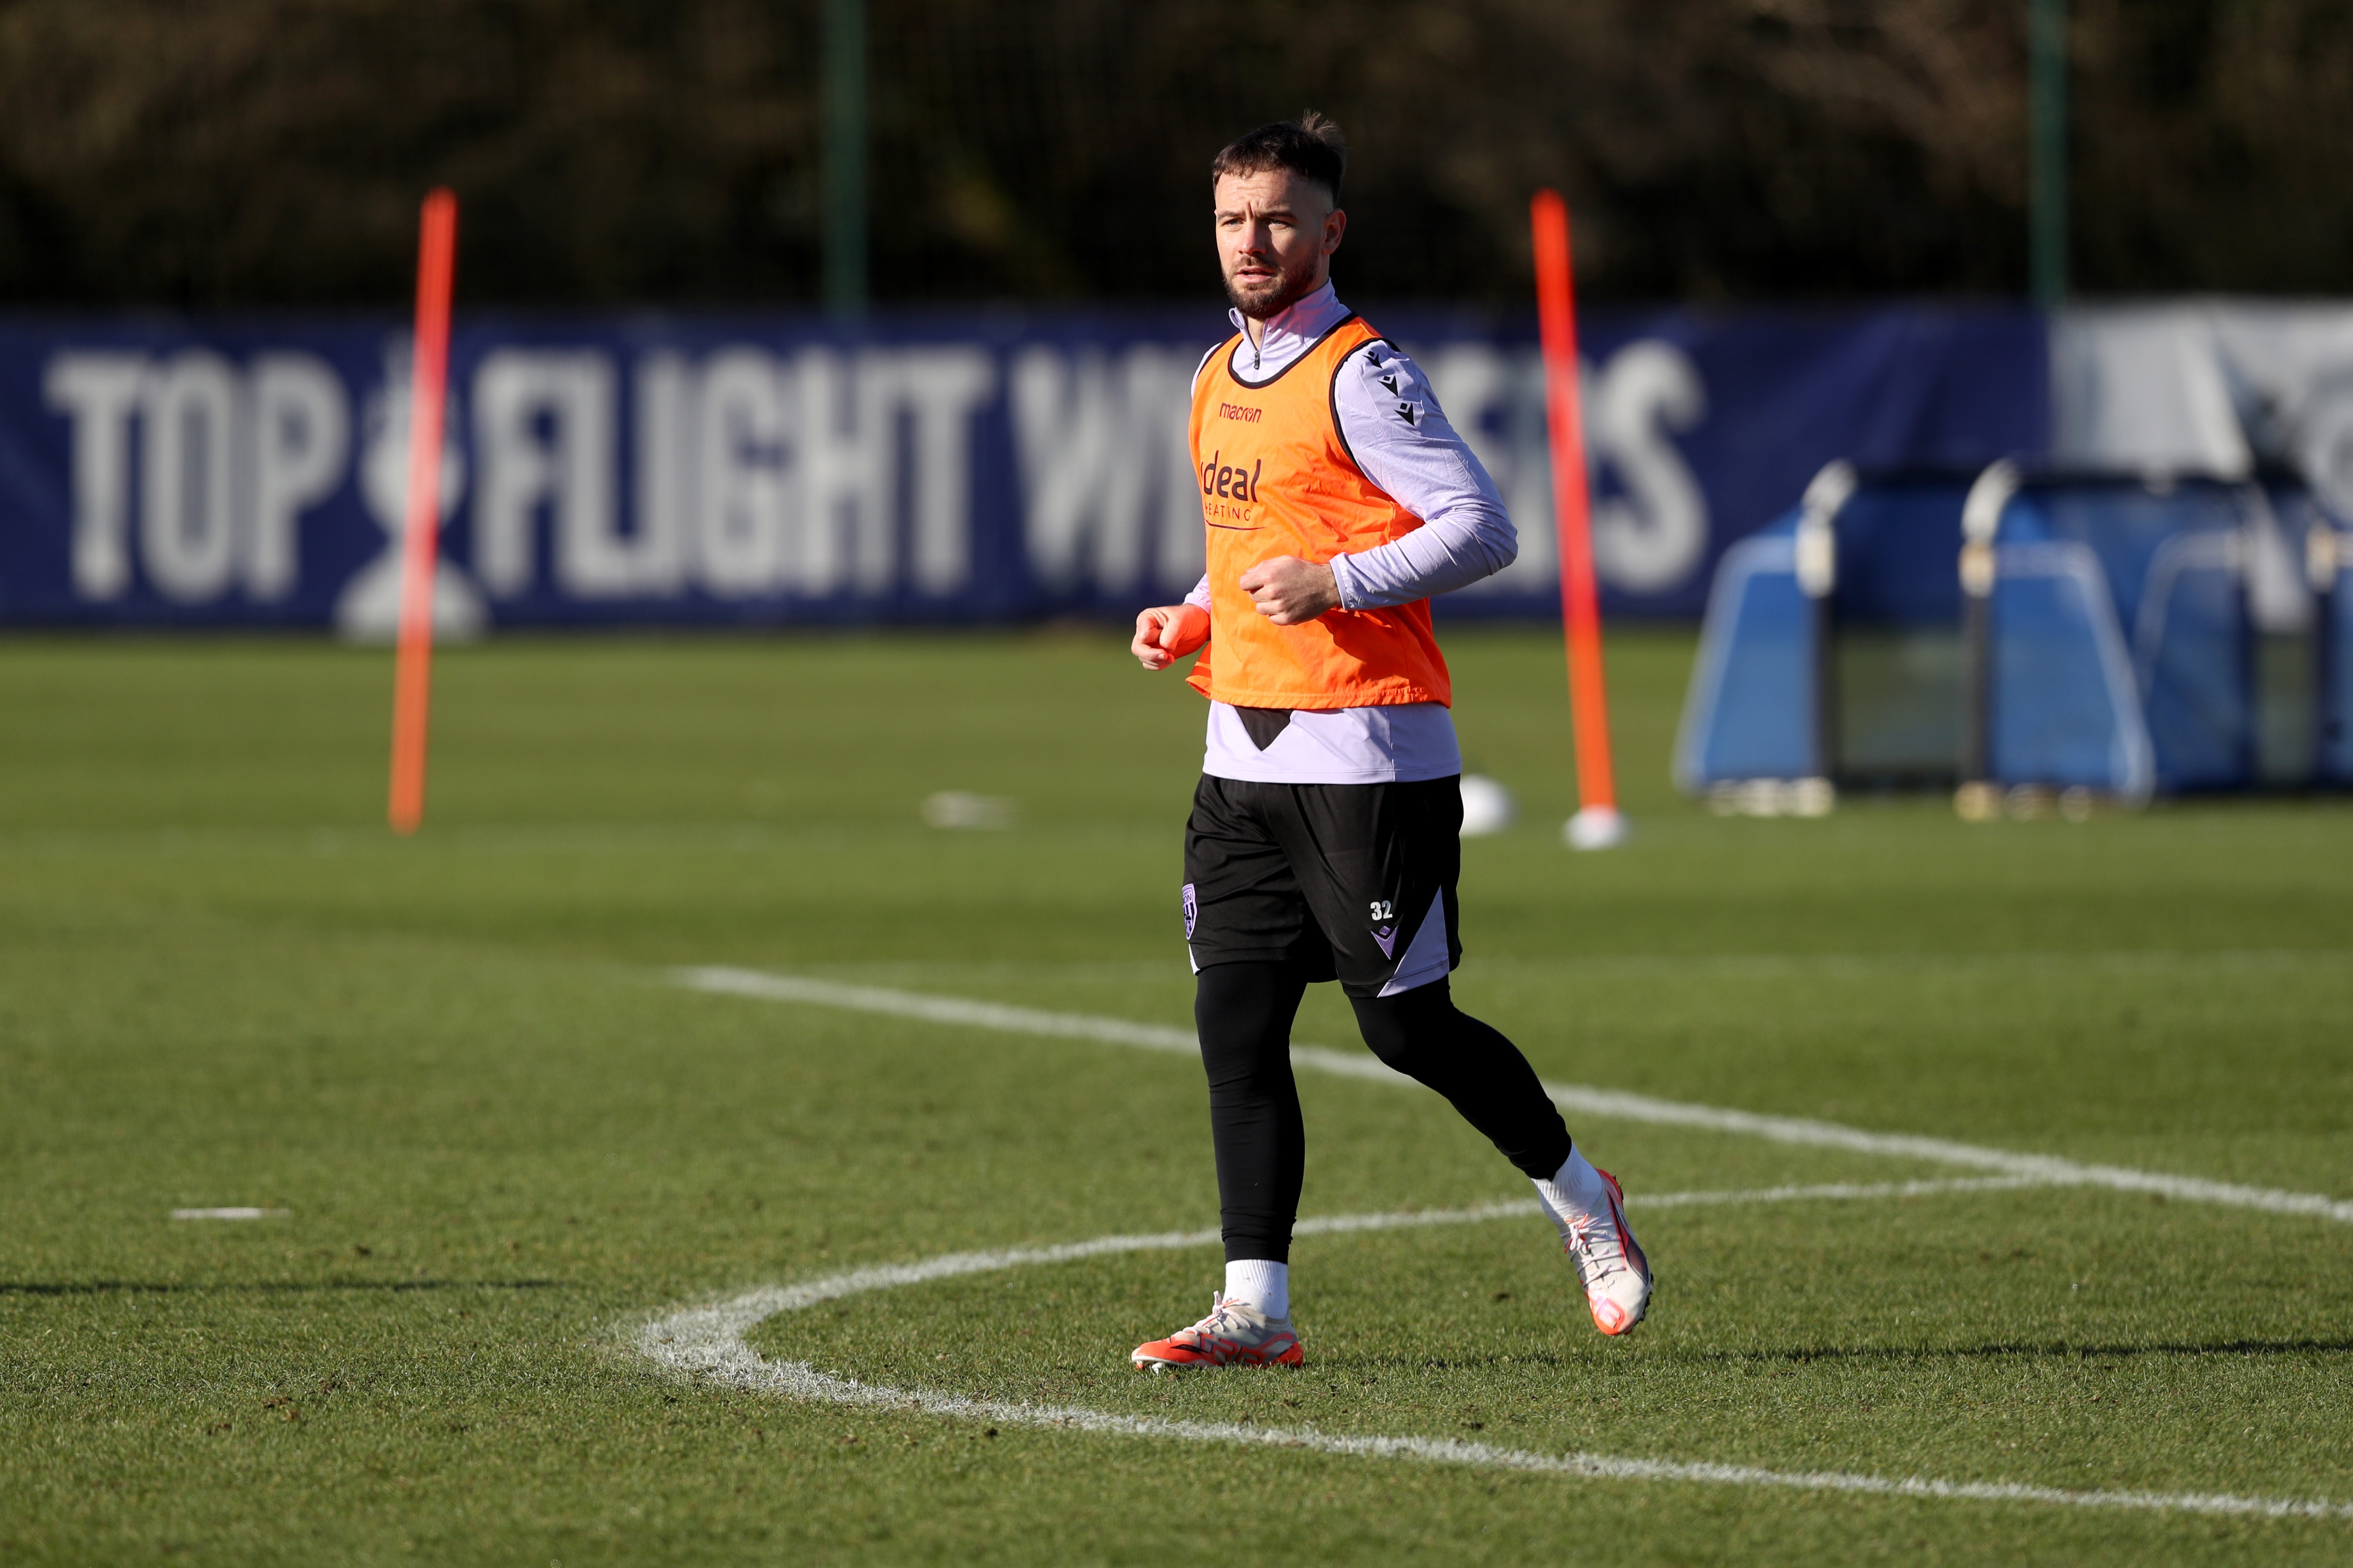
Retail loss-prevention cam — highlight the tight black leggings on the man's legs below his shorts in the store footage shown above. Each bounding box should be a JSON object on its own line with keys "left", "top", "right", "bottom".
{"left": 1193, "top": 964, "right": 1569, "bottom": 1262}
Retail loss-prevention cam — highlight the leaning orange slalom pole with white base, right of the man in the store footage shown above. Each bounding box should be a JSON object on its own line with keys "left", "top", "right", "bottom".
{"left": 1530, "top": 190, "right": 1626, "bottom": 849}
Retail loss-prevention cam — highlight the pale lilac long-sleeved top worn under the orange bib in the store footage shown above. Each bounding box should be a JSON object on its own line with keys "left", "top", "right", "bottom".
{"left": 1186, "top": 284, "right": 1520, "bottom": 783}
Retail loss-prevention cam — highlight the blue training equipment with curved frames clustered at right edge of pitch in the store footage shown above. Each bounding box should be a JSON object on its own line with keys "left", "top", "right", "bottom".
{"left": 1675, "top": 451, "right": 2353, "bottom": 802}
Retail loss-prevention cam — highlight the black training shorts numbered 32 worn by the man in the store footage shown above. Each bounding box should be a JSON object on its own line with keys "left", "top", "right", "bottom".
{"left": 1184, "top": 773, "right": 1464, "bottom": 997}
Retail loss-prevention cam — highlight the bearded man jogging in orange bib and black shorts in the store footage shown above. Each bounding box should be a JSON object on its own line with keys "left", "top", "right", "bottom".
{"left": 1134, "top": 113, "right": 1649, "bottom": 1371}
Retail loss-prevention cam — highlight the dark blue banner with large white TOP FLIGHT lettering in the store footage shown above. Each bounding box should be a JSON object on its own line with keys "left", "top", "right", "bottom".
{"left": 0, "top": 308, "right": 2052, "bottom": 637}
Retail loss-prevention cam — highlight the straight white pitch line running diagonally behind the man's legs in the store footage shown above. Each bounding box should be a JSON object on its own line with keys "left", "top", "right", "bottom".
{"left": 671, "top": 966, "right": 2353, "bottom": 1225}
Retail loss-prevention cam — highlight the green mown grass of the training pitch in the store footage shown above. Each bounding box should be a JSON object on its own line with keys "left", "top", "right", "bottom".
{"left": 0, "top": 630, "right": 2353, "bottom": 1568}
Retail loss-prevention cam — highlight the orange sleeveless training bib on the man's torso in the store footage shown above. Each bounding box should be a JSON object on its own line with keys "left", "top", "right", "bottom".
{"left": 1186, "top": 315, "right": 1454, "bottom": 710}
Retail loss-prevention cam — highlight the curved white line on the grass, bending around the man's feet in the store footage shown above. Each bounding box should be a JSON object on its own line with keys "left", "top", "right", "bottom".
{"left": 638, "top": 1178, "right": 2353, "bottom": 1519}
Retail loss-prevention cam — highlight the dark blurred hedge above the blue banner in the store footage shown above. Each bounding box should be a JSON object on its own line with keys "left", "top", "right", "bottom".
{"left": 0, "top": 0, "right": 2353, "bottom": 308}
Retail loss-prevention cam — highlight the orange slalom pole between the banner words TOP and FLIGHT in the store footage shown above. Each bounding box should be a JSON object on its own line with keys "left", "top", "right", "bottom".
{"left": 388, "top": 188, "right": 457, "bottom": 835}
